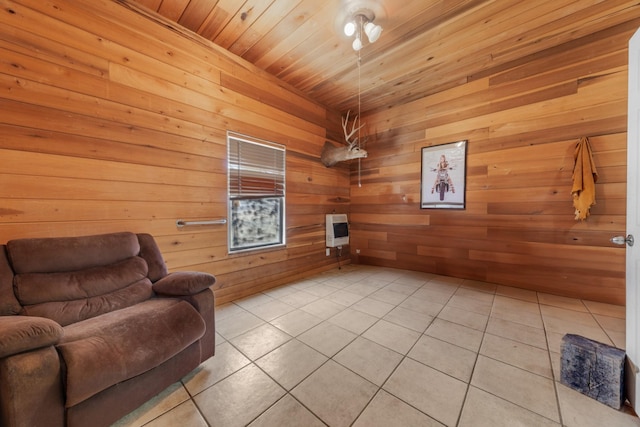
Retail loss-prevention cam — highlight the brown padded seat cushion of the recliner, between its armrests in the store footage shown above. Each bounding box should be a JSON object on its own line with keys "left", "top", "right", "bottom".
{"left": 57, "top": 298, "right": 206, "bottom": 408}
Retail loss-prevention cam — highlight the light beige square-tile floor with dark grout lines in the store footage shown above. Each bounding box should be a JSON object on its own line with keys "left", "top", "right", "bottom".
{"left": 115, "top": 265, "right": 640, "bottom": 427}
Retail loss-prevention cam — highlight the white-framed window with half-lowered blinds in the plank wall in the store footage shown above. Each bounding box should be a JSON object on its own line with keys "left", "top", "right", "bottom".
{"left": 227, "top": 132, "right": 286, "bottom": 252}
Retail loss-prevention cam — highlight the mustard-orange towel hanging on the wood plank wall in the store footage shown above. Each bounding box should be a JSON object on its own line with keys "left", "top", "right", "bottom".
{"left": 571, "top": 136, "right": 598, "bottom": 221}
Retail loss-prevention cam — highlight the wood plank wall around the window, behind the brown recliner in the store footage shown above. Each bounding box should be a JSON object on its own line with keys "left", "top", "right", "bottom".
{"left": 0, "top": 0, "right": 349, "bottom": 303}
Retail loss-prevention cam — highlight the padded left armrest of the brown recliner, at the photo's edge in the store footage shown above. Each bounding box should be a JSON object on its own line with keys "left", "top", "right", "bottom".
{"left": 0, "top": 316, "right": 64, "bottom": 358}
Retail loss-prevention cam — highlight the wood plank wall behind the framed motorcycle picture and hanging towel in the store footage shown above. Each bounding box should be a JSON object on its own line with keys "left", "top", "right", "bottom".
{"left": 351, "top": 18, "right": 640, "bottom": 304}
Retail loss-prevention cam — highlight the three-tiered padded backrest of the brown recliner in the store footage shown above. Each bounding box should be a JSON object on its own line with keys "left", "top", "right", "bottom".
{"left": 6, "top": 232, "right": 164, "bottom": 326}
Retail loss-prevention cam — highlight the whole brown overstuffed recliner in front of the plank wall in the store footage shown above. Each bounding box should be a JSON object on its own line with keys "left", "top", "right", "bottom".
{"left": 0, "top": 232, "right": 215, "bottom": 427}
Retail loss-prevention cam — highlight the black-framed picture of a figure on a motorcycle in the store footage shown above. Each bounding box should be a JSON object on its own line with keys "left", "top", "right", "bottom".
{"left": 420, "top": 140, "right": 467, "bottom": 209}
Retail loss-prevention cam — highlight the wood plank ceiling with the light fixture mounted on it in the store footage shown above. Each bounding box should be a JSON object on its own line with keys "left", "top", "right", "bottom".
{"left": 126, "top": 0, "right": 640, "bottom": 113}
